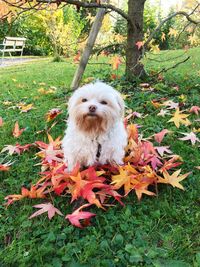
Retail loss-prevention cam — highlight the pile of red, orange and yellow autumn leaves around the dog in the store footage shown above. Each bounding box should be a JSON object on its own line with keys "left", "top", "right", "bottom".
{"left": 0, "top": 103, "right": 199, "bottom": 228}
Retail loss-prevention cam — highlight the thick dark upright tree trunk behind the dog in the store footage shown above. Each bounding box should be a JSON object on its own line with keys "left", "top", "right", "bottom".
{"left": 126, "top": 0, "right": 146, "bottom": 80}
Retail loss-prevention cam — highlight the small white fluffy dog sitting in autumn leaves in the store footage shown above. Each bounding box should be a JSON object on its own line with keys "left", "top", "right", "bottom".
{"left": 62, "top": 82, "right": 127, "bottom": 171}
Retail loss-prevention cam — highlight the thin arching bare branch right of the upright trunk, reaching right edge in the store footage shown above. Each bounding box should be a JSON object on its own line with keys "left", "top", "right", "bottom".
{"left": 144, "top": 4, "right": 200, "bottom": 48}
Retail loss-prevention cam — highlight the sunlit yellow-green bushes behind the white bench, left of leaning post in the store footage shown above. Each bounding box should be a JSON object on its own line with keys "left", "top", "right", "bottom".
{"left": 0, "top": 6, "right": 85, "bottom": 56}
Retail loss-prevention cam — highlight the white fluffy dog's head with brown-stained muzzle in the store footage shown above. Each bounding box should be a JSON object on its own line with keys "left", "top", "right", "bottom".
{"left": 68, "top": 82, "right": 124, "bottom": 134}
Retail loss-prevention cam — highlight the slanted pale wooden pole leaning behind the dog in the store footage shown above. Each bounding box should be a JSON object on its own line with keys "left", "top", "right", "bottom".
{"left": 71, "top": 8, "right": 106, "bottom": 90}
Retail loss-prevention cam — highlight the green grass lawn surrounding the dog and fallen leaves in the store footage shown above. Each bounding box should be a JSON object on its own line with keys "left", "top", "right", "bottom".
{"left": 0, "top": 48, "right": 200, "bottom": 267}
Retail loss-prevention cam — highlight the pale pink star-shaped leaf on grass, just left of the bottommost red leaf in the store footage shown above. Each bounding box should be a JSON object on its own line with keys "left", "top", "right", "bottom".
{"left": 29, "top": 203, "right": 63, "bottom": 220}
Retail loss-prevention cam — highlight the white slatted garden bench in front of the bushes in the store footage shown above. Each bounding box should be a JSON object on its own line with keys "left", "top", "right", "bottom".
{"left": 0, "top": 37, "right": 26, "bottom": 63}
